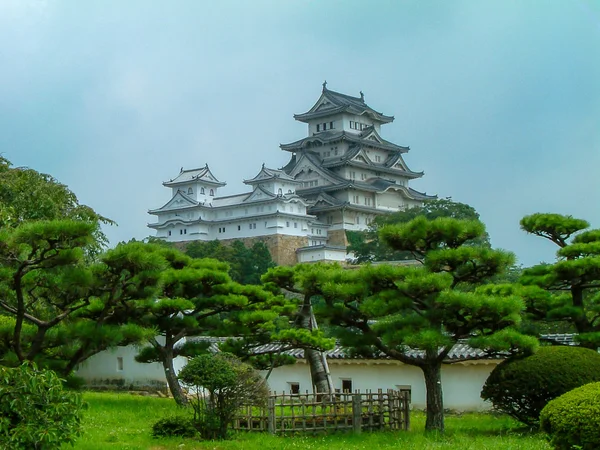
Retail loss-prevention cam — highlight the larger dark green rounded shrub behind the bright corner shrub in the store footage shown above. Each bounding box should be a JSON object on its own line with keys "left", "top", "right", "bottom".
{"left": 481, "top": 347, "right": 600, "bottom": 426}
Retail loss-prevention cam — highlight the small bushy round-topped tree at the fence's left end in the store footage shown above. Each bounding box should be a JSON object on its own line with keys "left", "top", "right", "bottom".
{"left": 179, "top": 353, "right": 269, "bottom": 439}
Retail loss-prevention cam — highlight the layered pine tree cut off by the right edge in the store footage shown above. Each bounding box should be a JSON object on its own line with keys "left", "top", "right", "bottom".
{"left": 521, "top": 213, "right": 600, "bottom": 349}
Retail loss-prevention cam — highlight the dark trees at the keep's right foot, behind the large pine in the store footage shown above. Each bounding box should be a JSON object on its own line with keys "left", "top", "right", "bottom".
{"left": 346, "top": 198, "right": 489, "bottom": 264}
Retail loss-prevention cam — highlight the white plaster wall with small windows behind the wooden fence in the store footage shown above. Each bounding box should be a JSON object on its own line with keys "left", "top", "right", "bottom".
{"left": 268, "top": 360, "right": 497, "bottom": 411}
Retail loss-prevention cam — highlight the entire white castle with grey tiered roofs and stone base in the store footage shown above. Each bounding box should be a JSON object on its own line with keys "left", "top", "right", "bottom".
{"left": 148, "top": 82, "right": 435, "bottom": 265}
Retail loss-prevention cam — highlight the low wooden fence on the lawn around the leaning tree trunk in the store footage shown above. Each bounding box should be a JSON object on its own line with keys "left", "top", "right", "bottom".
{"left": 233, "top": 389, "right": 410, "bottom": 434}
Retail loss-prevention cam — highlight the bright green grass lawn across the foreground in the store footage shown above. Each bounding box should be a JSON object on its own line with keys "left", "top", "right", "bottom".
{"left": 64, "top": 393, "right": 551, "bottom": 450}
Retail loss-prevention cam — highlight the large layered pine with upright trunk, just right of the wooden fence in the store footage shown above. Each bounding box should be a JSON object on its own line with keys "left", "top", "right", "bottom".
{"left": 314, "top": 217, "right": 537, "bottom": 431}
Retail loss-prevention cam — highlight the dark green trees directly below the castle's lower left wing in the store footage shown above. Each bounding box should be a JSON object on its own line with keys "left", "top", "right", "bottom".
{"left": 185, "top": 240, "right": 275, "bottom": 284}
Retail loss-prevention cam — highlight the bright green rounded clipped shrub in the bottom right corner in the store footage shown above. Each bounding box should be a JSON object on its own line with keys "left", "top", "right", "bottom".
{"left": 540, "top": 383, "right": 600, "bottom": 450}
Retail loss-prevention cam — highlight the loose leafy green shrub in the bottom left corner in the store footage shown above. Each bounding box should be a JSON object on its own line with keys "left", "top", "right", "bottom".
{"left": 0, "top": 363, "right": 83, "bottom": 450}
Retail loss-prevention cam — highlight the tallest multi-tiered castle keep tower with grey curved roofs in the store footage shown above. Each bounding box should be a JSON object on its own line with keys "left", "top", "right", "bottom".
{"left": 280, "top": 83, "right": 435, "bottom": 245}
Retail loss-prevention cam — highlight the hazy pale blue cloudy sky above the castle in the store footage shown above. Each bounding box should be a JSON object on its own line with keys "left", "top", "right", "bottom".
{"left": 0, "top": 0, "right": 600, "bottom": 266}
